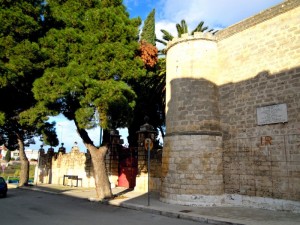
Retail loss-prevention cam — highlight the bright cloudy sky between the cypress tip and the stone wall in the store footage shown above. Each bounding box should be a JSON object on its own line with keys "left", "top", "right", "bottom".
{"left": 156, "top": 0, "right": 283, "bottom": 37}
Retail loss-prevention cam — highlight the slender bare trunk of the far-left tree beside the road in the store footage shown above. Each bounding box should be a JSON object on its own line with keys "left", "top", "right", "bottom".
{"left": 18, "top": 139, "right": 29, "bottom": 186}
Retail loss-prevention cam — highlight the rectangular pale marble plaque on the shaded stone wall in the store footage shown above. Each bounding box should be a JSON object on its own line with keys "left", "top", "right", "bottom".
{"left": 256, "top": 104, "right": 288, "bottom": 125}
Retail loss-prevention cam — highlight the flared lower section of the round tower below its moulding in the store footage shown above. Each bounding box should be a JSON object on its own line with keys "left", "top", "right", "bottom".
{"left": 160, "top": 135, "right": 224, "bottom": 205}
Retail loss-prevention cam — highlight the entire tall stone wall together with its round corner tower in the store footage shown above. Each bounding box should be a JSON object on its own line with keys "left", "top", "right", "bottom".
{"left": 161, "top": 0, "right": 300, "bottom": 212}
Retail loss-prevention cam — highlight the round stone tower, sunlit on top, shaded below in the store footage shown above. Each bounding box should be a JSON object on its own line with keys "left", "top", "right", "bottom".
{"left": 161, "top": 33, "right": 224, "bottom": 205}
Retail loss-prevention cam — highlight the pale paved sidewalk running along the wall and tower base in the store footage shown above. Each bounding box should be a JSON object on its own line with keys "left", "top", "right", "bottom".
{"left": 15, "top": 184, "right": 300, "bottom": 225}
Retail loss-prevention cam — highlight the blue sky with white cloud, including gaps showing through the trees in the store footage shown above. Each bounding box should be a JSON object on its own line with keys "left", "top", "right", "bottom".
{"left": 28, "top": 0, "right": 284, "bottom": 152}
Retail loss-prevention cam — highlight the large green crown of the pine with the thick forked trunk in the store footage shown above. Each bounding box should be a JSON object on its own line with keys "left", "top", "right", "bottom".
{"left": 28, "top": 0, "right": 145, "bottom": 146}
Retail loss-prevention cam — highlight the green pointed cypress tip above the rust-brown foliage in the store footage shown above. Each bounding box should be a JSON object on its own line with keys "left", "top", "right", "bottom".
{"left": 141, "top": 9, "right": 156, "bottom": 46}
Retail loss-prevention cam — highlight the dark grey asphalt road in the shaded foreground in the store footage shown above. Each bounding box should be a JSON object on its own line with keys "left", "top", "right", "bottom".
{"left": 0, "top": 189, "right": 204, "bottom": 225}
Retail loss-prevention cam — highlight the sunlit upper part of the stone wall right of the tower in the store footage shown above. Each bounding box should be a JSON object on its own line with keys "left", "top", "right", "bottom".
{"left": 215, "top": 0, "right": 300, "bottom": 85}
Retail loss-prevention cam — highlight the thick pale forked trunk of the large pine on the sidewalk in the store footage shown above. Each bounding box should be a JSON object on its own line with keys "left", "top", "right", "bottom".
{"left": 88, "top": 145, "right": 112, "bottom": 200}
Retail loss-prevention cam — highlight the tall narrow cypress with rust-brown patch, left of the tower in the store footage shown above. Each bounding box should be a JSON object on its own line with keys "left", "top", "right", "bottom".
{"left": 128, "top": 9, "right": 165, "bottom": 146}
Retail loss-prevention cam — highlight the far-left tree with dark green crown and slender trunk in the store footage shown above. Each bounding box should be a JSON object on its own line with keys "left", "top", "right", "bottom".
{"left": 0, "top": 0, "right": 55, "bottom": 186}
